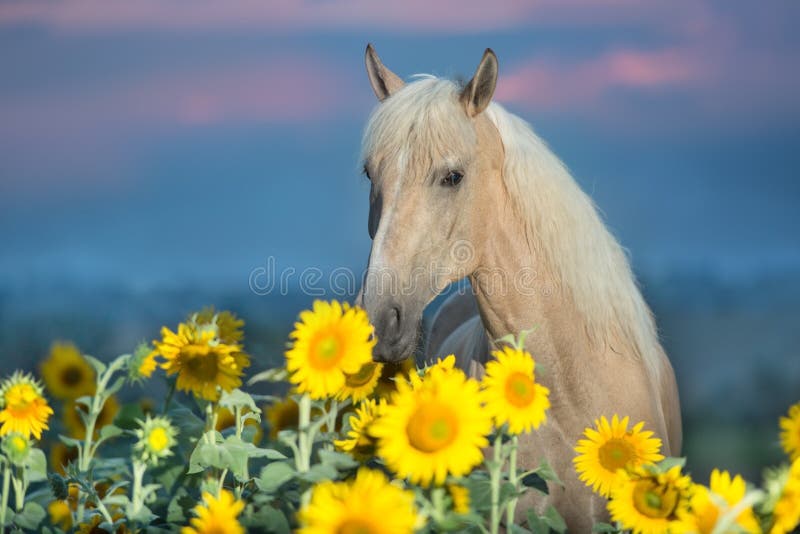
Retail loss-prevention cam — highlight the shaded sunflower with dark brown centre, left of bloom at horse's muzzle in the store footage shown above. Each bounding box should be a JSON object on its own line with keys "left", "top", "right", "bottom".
{"left": 154, "top": 314, "right": 250, "bottom": 401}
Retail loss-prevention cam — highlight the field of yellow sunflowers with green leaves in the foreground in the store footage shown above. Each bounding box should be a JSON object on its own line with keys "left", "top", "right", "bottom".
{"left": 0, "top": 301, "right": 800, "bottom": 534}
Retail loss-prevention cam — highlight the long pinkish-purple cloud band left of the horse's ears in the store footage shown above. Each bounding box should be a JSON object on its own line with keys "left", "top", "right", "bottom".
{"left": 0, "top": 57, "right": 356, "bottom": 195}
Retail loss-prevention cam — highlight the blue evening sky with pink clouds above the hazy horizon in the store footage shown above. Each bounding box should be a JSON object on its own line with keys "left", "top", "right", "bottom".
{"left": 0, "top": 0, "right": 800, "bottom": 292}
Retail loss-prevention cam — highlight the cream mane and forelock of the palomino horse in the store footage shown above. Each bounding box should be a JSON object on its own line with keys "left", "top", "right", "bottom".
{"left": 362, "top": 76, "right": 660, "bottom": 376}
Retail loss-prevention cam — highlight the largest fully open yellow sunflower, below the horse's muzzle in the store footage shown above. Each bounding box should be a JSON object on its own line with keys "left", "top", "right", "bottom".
{"left": 371, "top": 369, "right": 492, "bottom": 486}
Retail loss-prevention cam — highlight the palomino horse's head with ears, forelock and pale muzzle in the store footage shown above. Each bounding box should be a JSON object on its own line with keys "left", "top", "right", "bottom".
{"left": 362, "top": 46, "right": 502, "bottom": 361}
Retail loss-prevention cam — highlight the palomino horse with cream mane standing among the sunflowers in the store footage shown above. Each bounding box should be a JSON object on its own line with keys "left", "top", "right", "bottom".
{"left": 357, "top": 45, "right": 681, "bottom": 532}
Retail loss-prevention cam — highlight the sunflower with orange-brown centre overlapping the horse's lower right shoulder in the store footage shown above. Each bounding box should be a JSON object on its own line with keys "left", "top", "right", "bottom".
{"left": 572, "top": 414, "right": 664, "bottom": 497}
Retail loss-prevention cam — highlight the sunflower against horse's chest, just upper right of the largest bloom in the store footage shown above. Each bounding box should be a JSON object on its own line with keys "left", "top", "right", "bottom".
{"left": 482, "top": 347, "right": 550, "bottom": 434}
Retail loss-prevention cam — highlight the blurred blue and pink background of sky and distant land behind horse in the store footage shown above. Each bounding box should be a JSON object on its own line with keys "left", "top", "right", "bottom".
{"left": 0, "top": 0, "right": 800, "bottom": 479}
